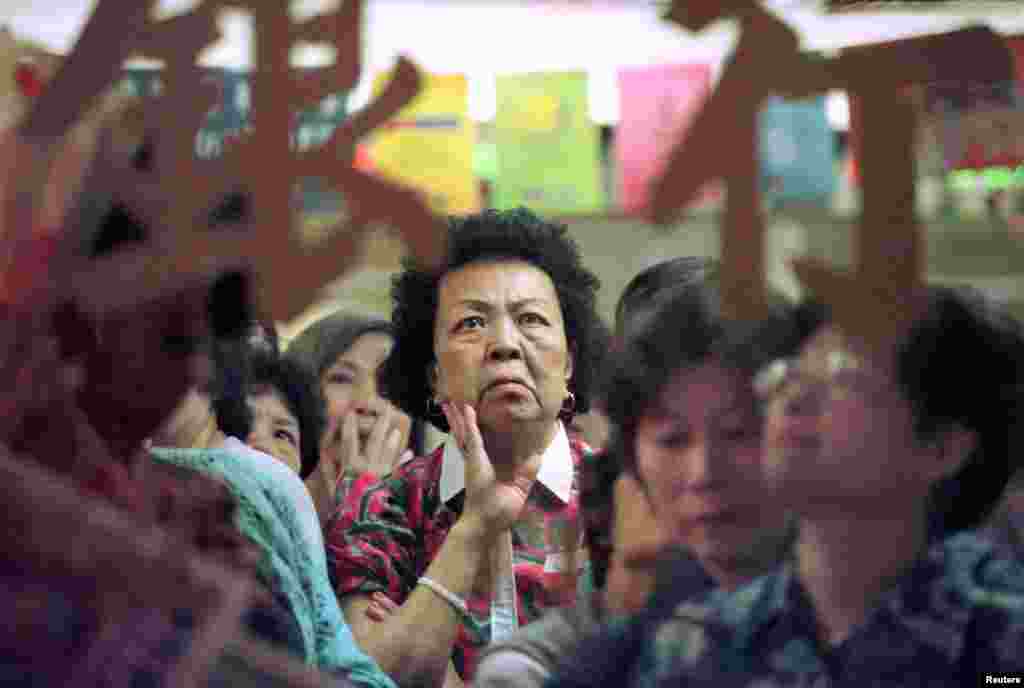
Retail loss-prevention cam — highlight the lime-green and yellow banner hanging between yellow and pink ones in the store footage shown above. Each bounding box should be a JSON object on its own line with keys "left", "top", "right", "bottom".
{"left": 492, "top": 72, "right": 605, "bottom": 214}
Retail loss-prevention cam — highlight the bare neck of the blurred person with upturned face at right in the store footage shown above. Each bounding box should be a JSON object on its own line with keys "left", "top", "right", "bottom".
{"left": 797, "top": 510, "right": 928, "bottom": 645}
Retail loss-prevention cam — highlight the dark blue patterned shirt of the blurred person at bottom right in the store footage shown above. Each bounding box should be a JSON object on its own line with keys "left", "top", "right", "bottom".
{"left": 585, "top": 533, "right": 1024, "bottom": 688}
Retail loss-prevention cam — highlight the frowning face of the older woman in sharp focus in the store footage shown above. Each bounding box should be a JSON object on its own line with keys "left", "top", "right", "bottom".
{"left": 434, "top": 261, "right": 572, "bottom": 438}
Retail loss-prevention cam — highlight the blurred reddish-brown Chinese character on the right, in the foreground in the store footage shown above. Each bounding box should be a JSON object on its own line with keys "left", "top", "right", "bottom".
{"left": 650, "top": 0, "right": 1012, "bottom": 355}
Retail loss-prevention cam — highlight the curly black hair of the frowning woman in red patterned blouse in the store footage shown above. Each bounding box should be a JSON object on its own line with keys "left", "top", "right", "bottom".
{"left": 381, "top": 208, "right": 600, "bottom": 432}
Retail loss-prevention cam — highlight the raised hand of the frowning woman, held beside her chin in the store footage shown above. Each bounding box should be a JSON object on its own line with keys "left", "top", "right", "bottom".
{"left": 441, "top": 402, "right": 534, "bottom": 536}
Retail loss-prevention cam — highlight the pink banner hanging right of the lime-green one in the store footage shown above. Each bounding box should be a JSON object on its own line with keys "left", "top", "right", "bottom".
{"left": 615, "top": 65, "right": 721, "bottom": 214}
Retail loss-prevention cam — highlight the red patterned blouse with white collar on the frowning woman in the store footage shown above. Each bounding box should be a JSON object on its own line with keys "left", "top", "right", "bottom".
{"left": 326, "top": 430, "right": 592, "bottom": 680}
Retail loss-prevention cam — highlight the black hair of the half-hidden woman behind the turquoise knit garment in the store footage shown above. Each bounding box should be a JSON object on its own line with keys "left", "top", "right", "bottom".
{"left": 206, "top": 340, "right": 326, "bottom": 480}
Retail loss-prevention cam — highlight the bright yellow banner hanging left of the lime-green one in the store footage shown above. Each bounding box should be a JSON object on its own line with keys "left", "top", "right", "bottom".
{"left": 370, "top": 74, "right": 480, "bottom": 215}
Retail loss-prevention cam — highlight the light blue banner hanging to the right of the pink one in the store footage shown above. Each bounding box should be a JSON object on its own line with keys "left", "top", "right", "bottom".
{"left": 759, "top": 95, "right": 837, "bottom": 203}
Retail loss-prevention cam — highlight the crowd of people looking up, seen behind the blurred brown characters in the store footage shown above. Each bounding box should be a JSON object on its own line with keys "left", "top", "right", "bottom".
{"left": 8, "top": 194, "right": 1024, "bottom": 687}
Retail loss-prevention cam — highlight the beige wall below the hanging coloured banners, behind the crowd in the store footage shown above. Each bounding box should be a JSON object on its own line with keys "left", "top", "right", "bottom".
{"left": 286, "top": 210, "right": 1024, "bottom": 335}
